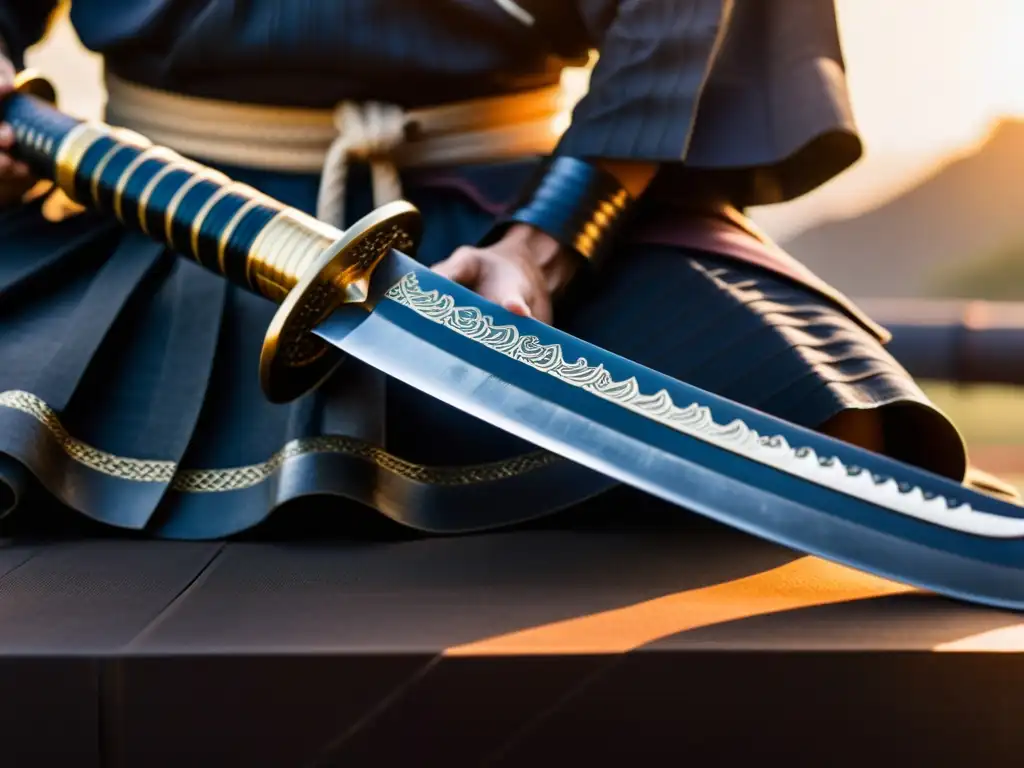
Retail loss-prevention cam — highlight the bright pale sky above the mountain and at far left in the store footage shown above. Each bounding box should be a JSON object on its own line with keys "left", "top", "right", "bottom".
{"left": 24, "top": 0, "right": 1024, "bottom": 237}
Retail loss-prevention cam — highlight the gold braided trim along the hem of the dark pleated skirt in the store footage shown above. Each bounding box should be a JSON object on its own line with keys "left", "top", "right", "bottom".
{"left": 0, "top": 390, "right": 560, "bottom": 494}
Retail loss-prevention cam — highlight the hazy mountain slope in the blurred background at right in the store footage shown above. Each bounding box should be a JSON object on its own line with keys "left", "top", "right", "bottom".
{"left": 782, "top": 119, "right": 1024, "bottom": 297}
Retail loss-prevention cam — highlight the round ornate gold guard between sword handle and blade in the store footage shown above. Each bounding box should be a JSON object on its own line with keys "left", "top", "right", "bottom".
{"left": 258, "top": 201, "right": 422, "bottom": 402}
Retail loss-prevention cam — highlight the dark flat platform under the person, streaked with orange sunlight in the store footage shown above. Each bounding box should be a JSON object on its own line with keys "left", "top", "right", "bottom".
{"left": 0, "top": 514, "right": 1024, "bottom": 768}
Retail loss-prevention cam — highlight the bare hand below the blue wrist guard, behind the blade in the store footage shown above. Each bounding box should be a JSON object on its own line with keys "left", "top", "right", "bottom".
{"left": 434, "top": 224, "right": 578, "bottom": 325}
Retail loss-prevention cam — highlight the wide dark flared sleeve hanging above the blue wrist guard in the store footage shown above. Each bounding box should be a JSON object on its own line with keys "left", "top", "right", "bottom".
{"left": 558, "top": 0, "right": 862, "bottom": 206}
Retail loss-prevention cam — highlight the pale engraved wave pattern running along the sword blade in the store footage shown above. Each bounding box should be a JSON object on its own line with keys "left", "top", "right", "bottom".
{"left": 385, "top": 272, "right": 1024, "bottom": 539}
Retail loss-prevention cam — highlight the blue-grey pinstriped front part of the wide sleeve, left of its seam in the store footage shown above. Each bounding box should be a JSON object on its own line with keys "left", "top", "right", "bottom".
{"left": 558, "top": 0, "right": 733, "bottom": 162}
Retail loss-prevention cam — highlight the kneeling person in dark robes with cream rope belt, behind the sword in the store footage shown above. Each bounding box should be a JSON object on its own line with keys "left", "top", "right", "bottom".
{"left": 0, "top": 0, "right": 1011, "bottom": 539}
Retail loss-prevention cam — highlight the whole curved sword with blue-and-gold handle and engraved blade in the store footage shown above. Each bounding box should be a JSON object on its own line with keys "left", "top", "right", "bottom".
{"left": 6, "top": 77, "right": 1024, "bottom": 608}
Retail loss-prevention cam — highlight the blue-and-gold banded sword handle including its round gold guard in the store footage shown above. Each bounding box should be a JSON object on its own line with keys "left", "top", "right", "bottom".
{"left": 0, "top": 73, "right": 421, "bottom": 402}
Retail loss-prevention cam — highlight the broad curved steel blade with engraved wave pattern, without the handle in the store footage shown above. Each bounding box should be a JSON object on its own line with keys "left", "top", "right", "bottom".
{"left": 316, "top": 252, "right": 1024, "bottom": 609}
